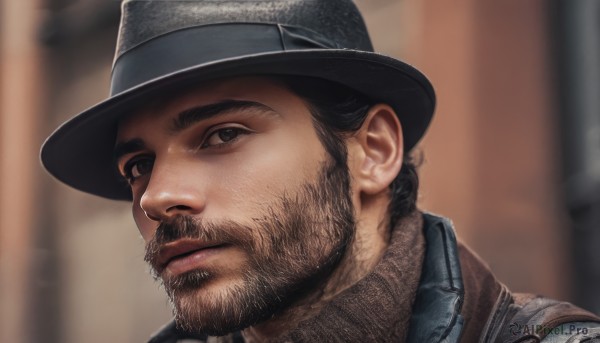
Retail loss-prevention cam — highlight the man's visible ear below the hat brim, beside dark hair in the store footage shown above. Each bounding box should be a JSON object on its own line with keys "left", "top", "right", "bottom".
{"left": 352, "top": 104, "right": 404, "bottom": 194}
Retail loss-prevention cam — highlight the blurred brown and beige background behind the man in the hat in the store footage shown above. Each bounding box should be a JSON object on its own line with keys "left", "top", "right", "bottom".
{"left": 0, "top": 0, "right": 600, "bottom": 342}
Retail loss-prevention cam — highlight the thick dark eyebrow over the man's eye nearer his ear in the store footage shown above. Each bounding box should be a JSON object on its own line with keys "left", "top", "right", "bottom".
{"left": 171, "top": 100, "right": 276, "bottom": 133}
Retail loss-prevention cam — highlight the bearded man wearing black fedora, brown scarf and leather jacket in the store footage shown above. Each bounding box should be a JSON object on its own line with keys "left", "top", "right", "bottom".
{"left": 42, "top": 0, "right": 600, "bottom": 342}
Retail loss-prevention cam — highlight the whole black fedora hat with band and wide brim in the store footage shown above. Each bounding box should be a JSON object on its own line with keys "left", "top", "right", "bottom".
{"left": 41, "top": 0, "right": 435, "bottom": 200}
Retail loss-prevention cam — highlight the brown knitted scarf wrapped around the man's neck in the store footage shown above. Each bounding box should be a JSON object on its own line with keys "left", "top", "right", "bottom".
{"left": 276, "top": 212, "right": 425, "bottom": 342}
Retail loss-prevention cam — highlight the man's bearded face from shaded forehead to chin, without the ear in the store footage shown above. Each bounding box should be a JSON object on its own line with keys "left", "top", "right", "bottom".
{"left": 116, "top": 78, "right": 355, "bottom": 335}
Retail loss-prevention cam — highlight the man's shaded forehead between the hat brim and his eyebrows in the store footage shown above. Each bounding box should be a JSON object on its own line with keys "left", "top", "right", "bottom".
{"left": 118, "top": 76, "right": 308, "bottom": 137}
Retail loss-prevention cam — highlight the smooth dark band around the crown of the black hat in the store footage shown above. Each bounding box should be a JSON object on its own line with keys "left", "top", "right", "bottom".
{"left": 110, "top": 23, "right": 339, "bottom": 96}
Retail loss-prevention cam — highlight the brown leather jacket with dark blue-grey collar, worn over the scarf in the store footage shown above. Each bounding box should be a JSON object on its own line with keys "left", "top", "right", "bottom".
{"left": 149, "top": 214, "right": 600, "bottom": 343}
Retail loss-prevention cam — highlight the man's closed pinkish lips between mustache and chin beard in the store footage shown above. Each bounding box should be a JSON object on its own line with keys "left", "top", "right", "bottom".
{"left": 158, "top": 240, "right": 222, "bottom": 274}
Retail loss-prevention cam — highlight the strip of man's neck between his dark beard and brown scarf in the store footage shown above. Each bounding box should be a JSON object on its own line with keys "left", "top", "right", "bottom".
{"left": 243, "top": 195, "right": 390, "bottom": 343}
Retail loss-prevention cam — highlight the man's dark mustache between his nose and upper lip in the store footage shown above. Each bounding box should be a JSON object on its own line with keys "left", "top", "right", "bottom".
{"left": 144, "top": 215, "right": 252, "bottom": 278}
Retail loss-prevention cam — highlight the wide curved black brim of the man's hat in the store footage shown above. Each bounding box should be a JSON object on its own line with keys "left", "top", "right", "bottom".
{"left": 41, "top": 49, "right": 435, "bottom": 200}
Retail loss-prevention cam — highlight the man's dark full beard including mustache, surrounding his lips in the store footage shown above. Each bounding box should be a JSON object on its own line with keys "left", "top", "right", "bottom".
{"left": 144, "top": 160, "right": 356, "bottom": 336}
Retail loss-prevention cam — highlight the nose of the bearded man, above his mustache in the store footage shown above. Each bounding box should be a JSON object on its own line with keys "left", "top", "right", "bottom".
{"left": 139, "top": 160, "right": 205, "bottom": 221}
